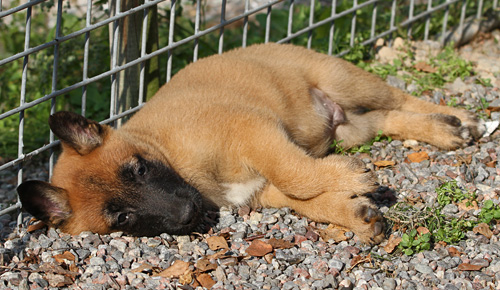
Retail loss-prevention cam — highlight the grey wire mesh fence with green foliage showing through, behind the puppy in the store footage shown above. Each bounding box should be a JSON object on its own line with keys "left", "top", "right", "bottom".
{"left": 0, "top": 0, "right": 498, "bottom": 223}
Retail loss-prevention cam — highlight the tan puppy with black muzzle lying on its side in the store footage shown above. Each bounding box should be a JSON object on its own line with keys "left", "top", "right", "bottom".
{"left": 18, "top": 44, "right": 480, "bottom": 243}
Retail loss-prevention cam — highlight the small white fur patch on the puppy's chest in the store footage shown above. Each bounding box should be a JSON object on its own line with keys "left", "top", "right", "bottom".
{"left": 222, "top": 177, "right": 266, "bottom": 206}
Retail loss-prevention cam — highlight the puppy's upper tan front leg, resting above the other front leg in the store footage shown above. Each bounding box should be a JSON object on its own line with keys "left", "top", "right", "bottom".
{"left": 238, "top": 119, "right": 378, "bottom": 200}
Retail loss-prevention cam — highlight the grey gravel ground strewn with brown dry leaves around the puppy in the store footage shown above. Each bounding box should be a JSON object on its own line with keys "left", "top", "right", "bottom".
{"left": 0, "top": 31, "right": 500, "bottom": 290}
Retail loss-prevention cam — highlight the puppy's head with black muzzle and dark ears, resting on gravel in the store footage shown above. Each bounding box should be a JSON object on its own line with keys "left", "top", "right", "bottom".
{"left": 17, "top": 112, "right": 203, "bottom": 236}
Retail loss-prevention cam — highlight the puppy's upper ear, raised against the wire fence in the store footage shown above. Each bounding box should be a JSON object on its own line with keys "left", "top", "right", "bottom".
{"left": 49, "top": 112, "right": 111, "bottom": 155}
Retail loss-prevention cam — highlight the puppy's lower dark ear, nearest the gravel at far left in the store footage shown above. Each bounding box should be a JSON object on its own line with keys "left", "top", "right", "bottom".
{"left": 17, "top": 180, "right": 71, "bottom": 227}
